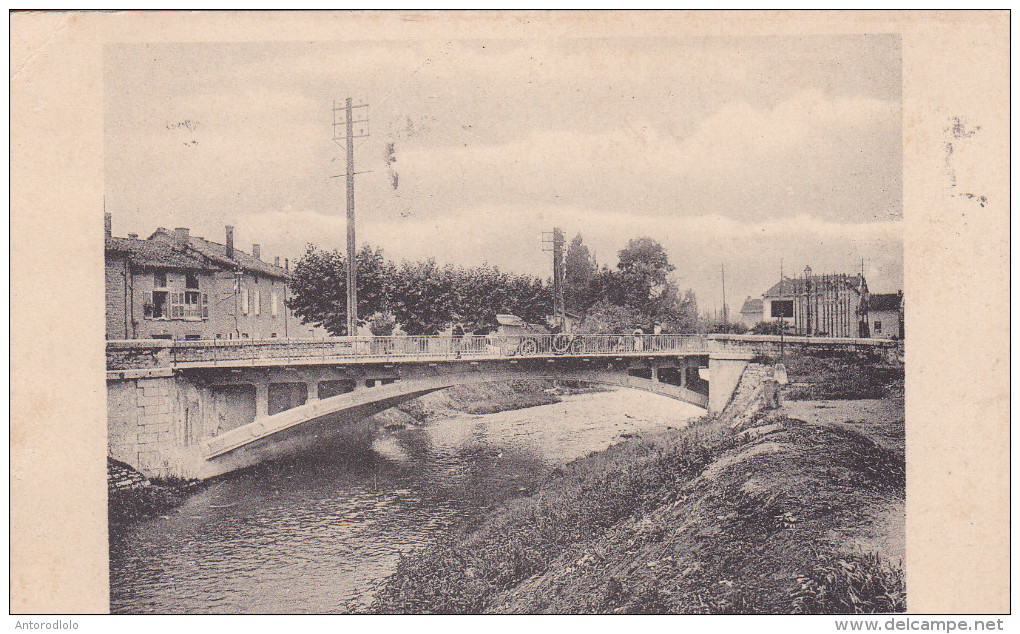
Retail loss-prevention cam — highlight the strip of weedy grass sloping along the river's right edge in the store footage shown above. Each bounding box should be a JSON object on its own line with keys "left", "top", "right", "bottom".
{"left": 373, "top": 429, "right": 721, "bottom": 614}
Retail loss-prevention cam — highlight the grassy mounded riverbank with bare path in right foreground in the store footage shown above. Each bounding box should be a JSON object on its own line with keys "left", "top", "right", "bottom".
{"left": 371, "top": 358, "right": 906, "bottom": 614}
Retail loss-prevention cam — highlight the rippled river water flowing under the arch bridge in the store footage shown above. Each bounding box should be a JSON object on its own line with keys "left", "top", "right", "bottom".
{"left": 110, "top": 390, "right": 703, "bottom": 614}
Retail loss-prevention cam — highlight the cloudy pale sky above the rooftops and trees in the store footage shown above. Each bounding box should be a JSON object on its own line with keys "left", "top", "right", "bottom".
{"left": 104, "top": 35, "right": 903, "bottom": 314}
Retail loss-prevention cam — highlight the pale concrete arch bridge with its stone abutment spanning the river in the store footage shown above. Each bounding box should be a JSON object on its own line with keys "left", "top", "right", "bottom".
{"left": 107, "top": 334, "right": 895, "bottom": 478}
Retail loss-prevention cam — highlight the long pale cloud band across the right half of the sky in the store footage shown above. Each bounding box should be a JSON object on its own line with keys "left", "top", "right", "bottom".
{"left": 389, "top": 91, "right": 902, "bottom": 221}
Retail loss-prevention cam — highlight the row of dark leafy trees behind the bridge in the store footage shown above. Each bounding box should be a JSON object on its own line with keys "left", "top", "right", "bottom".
{"left": 288, "top": 234, "right": 698, "bottom": 335}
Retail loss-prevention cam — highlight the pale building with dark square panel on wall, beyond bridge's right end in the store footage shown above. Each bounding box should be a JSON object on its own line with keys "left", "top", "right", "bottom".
{"left": 762, "top": 266, "right": 870, "bottom": 337}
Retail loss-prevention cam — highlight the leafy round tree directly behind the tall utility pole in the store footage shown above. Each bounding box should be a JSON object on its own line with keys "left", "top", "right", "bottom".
{"left": 287, "top": 245, "right": 394, "bottom": 335}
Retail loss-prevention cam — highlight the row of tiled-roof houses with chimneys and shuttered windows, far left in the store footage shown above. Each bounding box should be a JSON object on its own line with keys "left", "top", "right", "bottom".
{"left": 105, "top": 214, "right": 323, "bottom": 339}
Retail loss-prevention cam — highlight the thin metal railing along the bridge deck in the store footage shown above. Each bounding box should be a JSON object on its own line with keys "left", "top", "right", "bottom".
{"left": 157, "top": 334, "right": 709, "bottom": 365}
